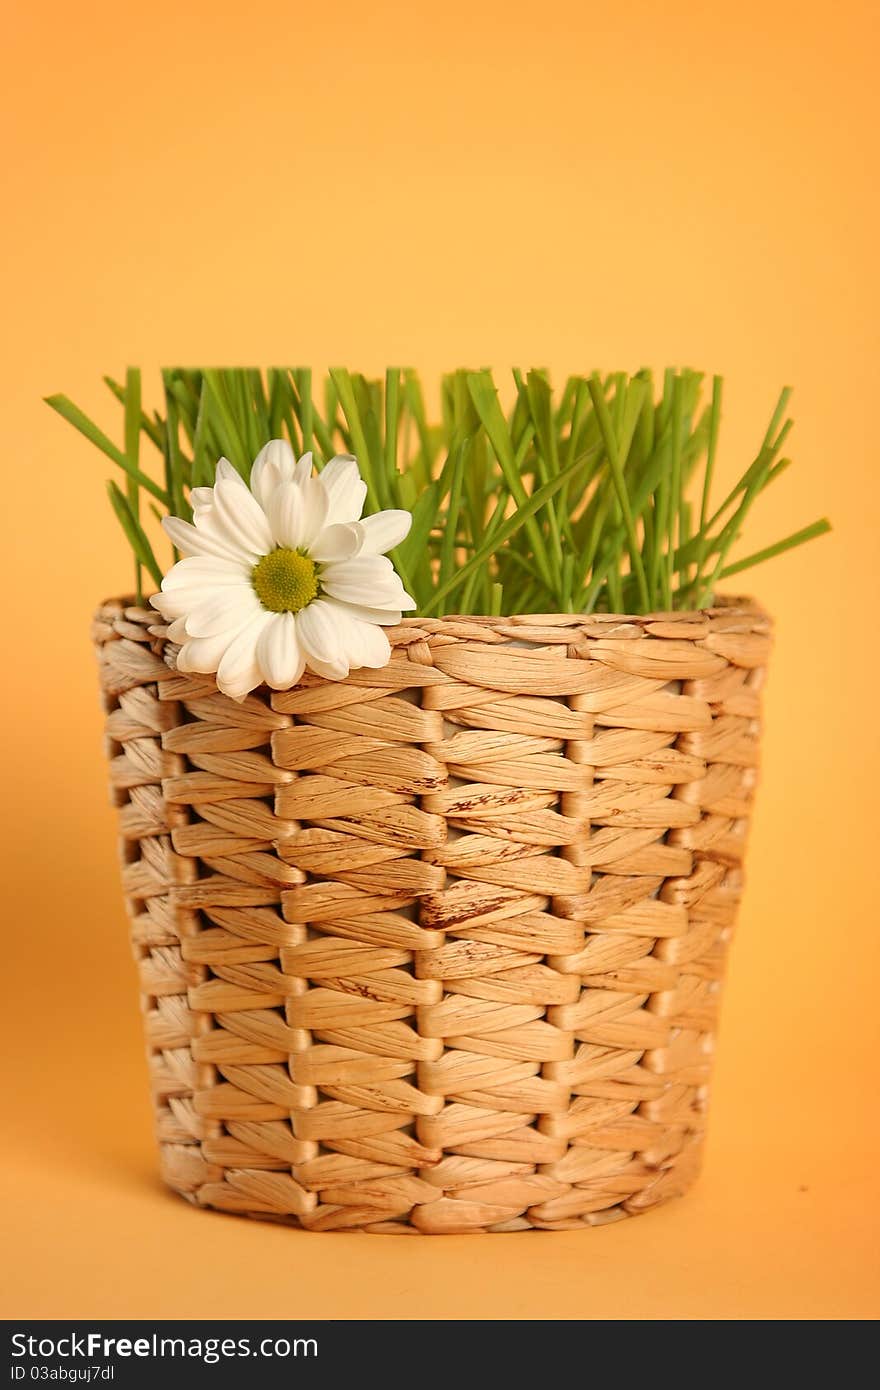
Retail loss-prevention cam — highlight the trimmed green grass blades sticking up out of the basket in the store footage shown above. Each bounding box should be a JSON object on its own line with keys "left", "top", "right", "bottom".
{"left": 47, "top": 367, "right": 830, "bottom": 616}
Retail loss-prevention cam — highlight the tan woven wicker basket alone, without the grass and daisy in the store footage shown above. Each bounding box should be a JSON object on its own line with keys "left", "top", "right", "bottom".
{"left": 95, "top": 600, "right": 770, "bottom": 1233}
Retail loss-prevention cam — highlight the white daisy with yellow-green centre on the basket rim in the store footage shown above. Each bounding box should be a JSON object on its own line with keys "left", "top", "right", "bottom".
{"left": 150, "top": 439, "right": 416, "bottom": 701}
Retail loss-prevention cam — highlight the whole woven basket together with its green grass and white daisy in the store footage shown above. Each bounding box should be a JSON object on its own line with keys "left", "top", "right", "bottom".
{"left": 50, "top": 368, "right": 829, "bottom": 1233}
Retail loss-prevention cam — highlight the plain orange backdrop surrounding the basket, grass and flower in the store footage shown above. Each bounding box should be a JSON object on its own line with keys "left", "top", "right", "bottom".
{"left": 0, "top": 0, "right": 880, "bottom": 1318}
